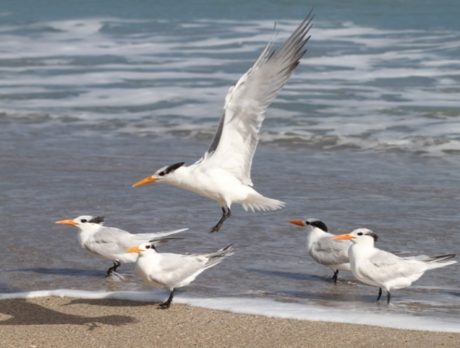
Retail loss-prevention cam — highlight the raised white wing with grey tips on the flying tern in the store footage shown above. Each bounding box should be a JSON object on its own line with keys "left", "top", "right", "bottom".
{"left": 199, "top": 12, "right": 313, "bottom": 185}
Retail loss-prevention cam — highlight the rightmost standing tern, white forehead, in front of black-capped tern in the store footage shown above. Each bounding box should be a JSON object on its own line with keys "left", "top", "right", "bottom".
{"left": 332, "top": 228, "right": 457, "bottom": 303}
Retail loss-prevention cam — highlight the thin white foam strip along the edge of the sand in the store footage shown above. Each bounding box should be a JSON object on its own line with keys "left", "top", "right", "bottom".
{"left": 0, "top": 289, "right": 460, "bottom": 332}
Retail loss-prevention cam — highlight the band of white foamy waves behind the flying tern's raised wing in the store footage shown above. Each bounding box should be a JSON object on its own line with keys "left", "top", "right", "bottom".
{"left": 0, "top": 18, "right": 460, "bottom": 155}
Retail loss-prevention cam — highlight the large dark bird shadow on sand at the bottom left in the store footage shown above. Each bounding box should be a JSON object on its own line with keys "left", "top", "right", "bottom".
{"left": 0, "top": 299, "right": 137, "bottom": 330}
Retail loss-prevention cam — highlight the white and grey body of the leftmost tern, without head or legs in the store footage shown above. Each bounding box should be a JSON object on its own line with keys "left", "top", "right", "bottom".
{"left": 78, "top": 224, "right": 187, "bottom": 263}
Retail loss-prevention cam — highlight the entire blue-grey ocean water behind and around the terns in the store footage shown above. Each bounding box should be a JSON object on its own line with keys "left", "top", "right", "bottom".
{"left": 0, "top": 0, "right": 460, "bottom": 331}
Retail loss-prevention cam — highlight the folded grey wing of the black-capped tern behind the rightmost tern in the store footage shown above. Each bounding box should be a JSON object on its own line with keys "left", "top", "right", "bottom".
{"left": 310, "top": 235, "right": 351, "bottom": 265}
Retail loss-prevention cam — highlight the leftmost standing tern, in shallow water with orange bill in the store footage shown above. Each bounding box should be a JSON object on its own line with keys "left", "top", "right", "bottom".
{"left": 56, "top": 215, "right": 188, "bottom": 277}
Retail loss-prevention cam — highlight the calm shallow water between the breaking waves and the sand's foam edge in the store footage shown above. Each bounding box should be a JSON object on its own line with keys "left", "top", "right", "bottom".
{"left": 0, "top": 126, "right": 460, "bottom": 328}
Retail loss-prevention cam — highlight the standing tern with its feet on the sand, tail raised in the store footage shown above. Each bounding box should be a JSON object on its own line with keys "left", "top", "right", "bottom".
{"left": 128, "top": 243, "right": 233, "bottom": 309}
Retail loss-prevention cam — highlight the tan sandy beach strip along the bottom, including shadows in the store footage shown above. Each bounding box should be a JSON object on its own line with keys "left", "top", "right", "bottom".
{"left": 0, "top": 297, "right": 460, "bottom": 348}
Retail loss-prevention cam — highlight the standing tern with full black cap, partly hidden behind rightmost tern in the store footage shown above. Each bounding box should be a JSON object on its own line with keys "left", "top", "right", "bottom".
{"left": 289, "top": 218, "right": 351, "bottom": 283}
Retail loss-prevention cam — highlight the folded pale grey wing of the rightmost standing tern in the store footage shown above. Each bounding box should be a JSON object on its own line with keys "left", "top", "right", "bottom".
{"left": 360, "top": 250, "right": 424, "bottom": 284}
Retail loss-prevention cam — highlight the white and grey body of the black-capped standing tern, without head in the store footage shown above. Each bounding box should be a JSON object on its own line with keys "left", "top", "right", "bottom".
{"left": 307, "top": 226, "right": 351, "bottom": 271}
